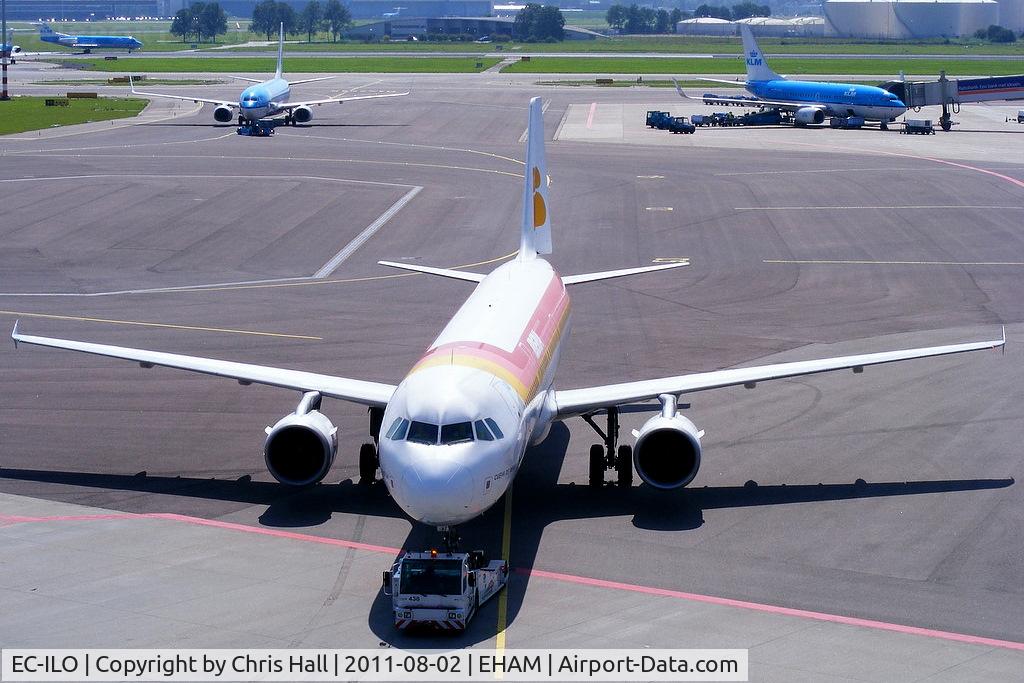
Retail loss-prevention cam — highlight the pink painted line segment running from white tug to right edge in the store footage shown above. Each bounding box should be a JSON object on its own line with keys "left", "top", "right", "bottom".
{"left": 516, "top": 569, "right": 1024, "bottom": 650}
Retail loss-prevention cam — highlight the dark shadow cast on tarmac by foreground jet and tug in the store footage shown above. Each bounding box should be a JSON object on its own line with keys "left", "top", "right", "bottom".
{"left": 0, "top": 430, "right": 1014, "bottom": 649}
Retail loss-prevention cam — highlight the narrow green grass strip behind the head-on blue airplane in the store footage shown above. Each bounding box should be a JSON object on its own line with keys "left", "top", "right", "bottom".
{"left": 65, "top": 56, "right": 500, "bottom": 74}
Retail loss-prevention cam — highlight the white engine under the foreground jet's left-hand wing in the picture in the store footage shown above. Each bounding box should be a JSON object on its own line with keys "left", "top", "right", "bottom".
{"left": 263, "top": 411, "right": 338, "bottom": 486}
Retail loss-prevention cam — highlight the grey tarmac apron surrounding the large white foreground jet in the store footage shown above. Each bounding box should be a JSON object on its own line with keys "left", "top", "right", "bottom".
{"left": 0, "top": 63, "right": 1024, "bottom": 681}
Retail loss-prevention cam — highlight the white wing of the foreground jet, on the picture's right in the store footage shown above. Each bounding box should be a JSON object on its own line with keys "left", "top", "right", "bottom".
{"left": 555, "top": 328, "right": 1007, "bottom": 419}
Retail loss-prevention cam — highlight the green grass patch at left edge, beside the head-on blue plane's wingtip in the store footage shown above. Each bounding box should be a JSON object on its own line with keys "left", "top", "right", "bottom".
{"left": 0, "top": 97, "right": 147, "bottom": 135}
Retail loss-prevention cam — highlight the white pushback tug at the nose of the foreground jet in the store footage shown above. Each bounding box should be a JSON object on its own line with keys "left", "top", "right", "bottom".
{"left": 384, "top": 550, "right": 509, "bottom": 631}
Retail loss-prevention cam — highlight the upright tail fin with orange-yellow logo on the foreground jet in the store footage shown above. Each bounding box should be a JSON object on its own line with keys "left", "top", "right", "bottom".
{"left": 519, "top": 97, "right": 551, "bottom": 259}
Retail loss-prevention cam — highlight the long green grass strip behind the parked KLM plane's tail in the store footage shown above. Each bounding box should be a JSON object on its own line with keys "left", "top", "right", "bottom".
{"left": 502, "top": 56, "right": 1024, "bottom": 76}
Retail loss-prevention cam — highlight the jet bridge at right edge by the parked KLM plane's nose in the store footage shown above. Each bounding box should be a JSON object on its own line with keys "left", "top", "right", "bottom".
{"left": 882, "top": 72, "right": 1024, "bottom": 130}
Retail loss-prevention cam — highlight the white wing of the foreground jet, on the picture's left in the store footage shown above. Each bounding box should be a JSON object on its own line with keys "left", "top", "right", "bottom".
{"left": 10, "top": 323, "right": 395, "bottom": 408}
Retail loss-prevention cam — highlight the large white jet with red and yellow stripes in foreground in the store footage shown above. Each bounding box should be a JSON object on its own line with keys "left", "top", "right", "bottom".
{"left": 12, "top": 97, "right": 1006, "bottom": 531}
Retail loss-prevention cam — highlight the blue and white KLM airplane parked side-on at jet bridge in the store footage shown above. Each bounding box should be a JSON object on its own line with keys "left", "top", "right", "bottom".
{"left": 673, "top": 26, "right": 906, "bottom": 129}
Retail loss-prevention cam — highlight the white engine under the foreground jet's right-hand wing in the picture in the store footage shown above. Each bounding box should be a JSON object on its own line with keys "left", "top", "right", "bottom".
{"left": 633, "top": 413, "right": 701, "bottom": 489}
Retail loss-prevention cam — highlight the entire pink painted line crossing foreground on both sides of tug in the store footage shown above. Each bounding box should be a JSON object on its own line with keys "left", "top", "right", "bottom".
{"left": 9, "top": 513, "right": 1024, "bottom": 651}
